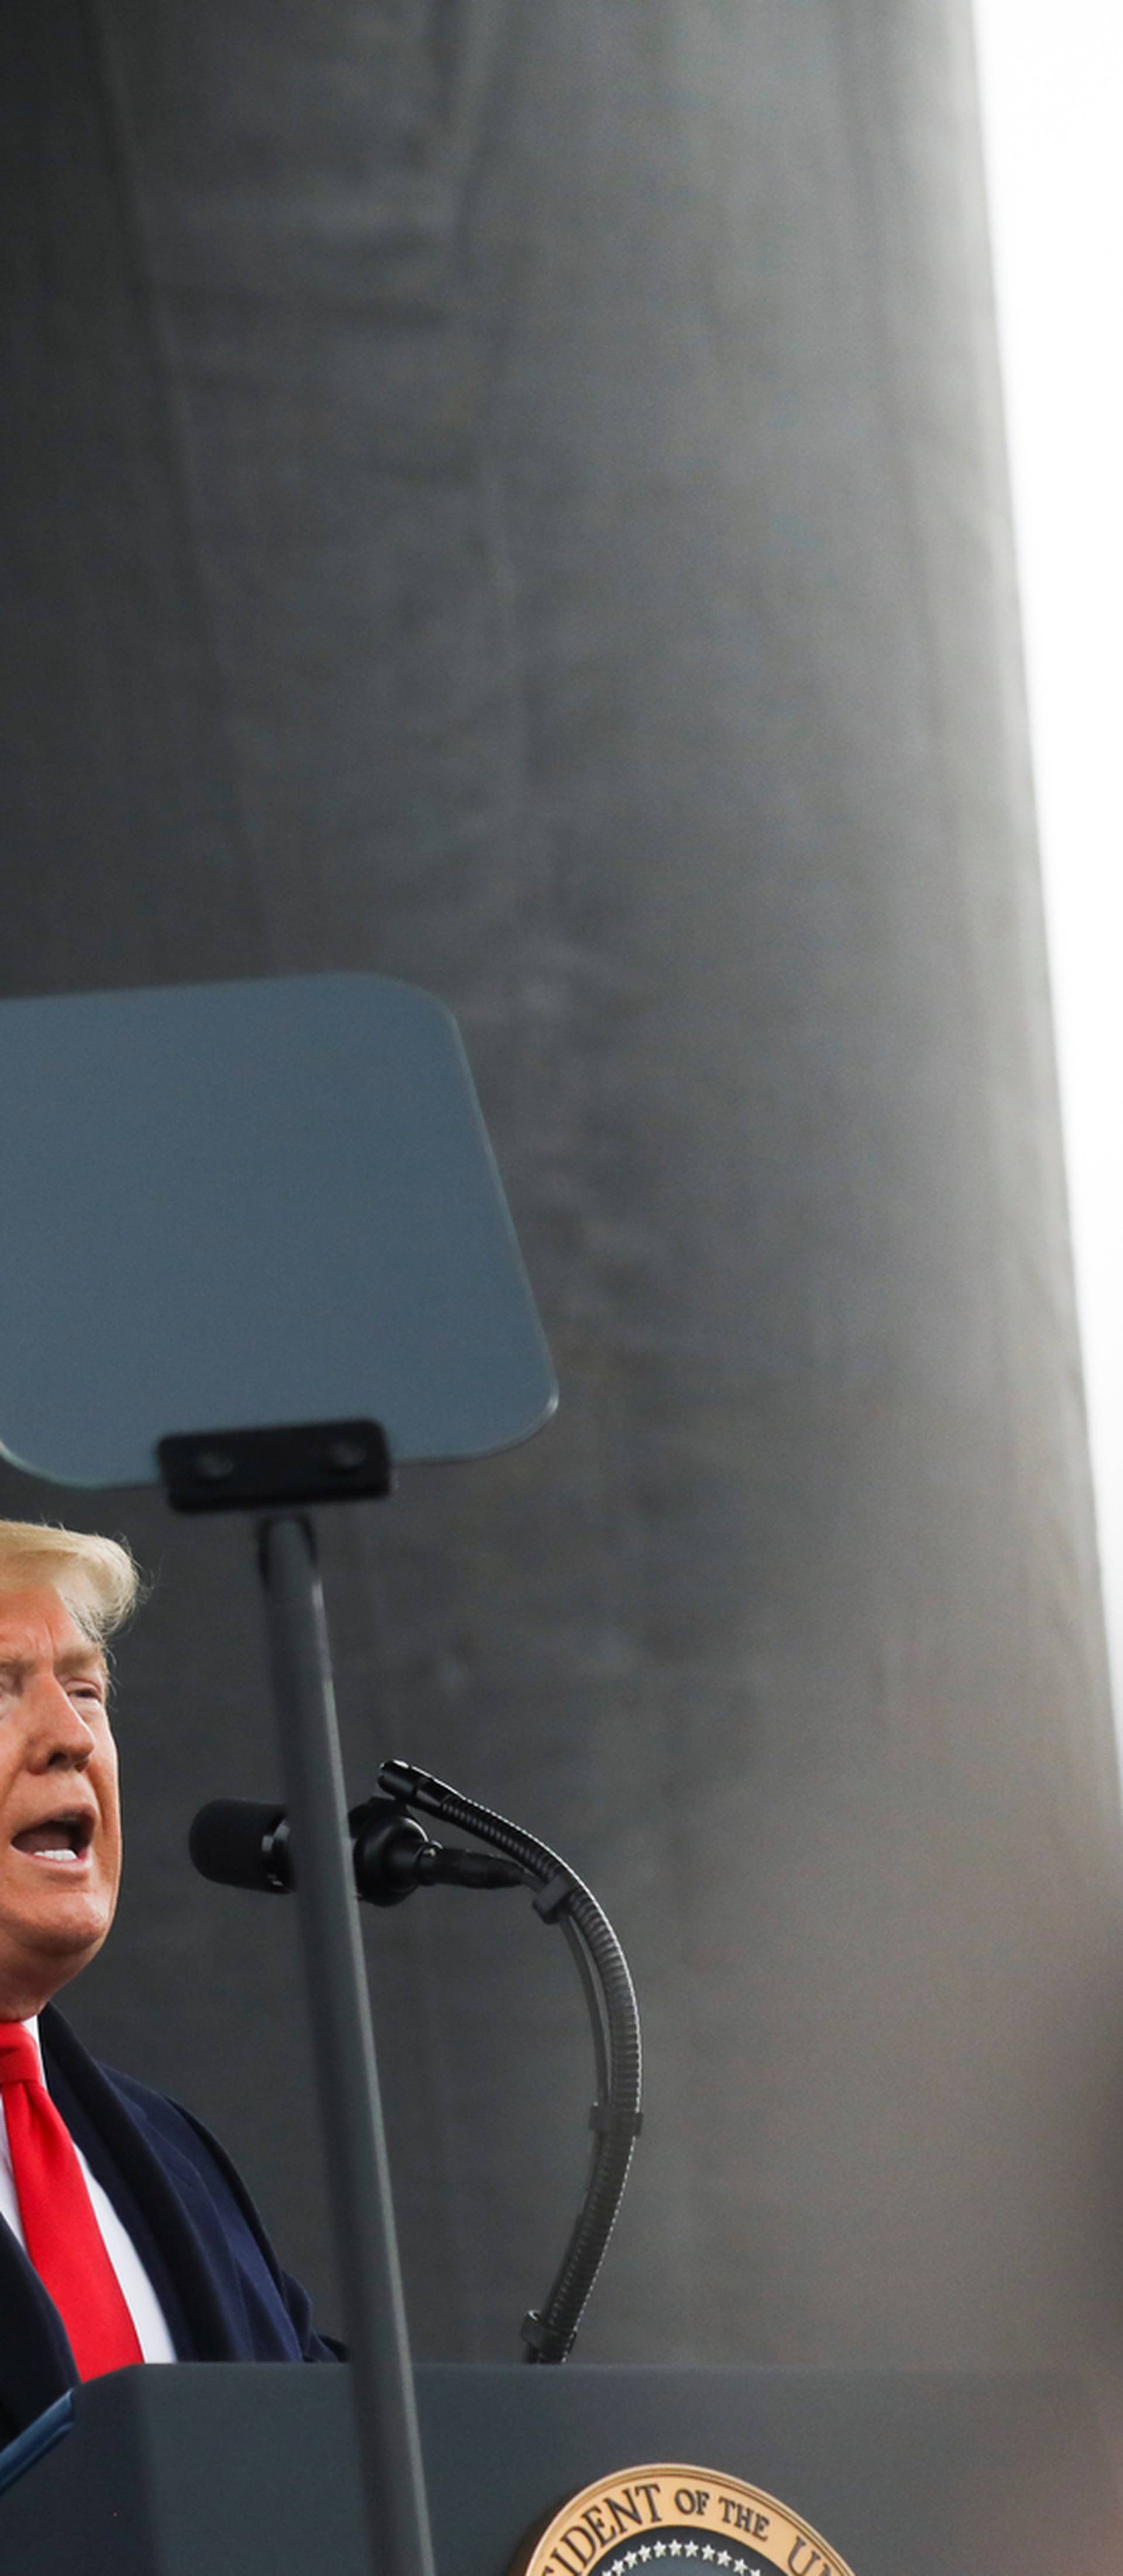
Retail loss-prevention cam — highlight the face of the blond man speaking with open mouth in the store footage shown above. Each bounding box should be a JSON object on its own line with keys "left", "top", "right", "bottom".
{"left": 0, "top": 1584, "right": 121, "bottom": 2022}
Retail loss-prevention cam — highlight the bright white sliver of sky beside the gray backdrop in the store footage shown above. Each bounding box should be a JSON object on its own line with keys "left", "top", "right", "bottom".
{"left": 974, "top": 0, "right": 1123, "bottom": 1726}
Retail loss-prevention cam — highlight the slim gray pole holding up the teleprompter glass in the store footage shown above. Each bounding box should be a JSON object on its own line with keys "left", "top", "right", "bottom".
{"left": 257, "top": 1512, "right": 433, "bottom": 2576}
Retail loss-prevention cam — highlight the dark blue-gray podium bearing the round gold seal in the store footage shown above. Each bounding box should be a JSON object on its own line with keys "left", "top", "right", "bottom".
{"left": 0, "top": 2362, "right": 1123, "bottom": 2576}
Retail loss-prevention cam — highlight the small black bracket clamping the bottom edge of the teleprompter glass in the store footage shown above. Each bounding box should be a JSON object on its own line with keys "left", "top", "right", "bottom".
{"left": 157, "top": 1422, "right": 394, "bottom": 1512}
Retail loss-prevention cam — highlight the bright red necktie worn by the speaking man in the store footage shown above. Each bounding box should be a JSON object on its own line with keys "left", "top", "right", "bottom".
{"left": 0, "top": 2022, "right": 144, "bottom": 2380}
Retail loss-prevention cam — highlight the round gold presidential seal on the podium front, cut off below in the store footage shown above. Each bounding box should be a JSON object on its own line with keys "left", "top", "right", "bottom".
{"left": 510, "top": 2463, "right": 853, "bottom": 2576}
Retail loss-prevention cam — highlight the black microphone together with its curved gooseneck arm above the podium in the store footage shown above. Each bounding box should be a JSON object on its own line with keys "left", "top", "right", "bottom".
{"left": 191, "top": 1762, "right": 642, "bottom": 2362}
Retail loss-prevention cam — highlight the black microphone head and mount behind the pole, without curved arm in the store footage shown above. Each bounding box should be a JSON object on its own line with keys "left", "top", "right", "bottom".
{"left": 188, "top": 1798, "right": 525, "bottom": 1906}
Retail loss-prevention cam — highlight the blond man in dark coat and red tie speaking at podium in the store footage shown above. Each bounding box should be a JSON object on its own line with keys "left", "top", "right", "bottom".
{"left": 0, "top": 1520, "right": 337, "bottom": 2442}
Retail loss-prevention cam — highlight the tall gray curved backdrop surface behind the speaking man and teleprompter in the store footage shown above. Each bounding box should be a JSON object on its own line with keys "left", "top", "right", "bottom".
{"left": 0, "top": 0, "right": 1121, "bottom": 2362}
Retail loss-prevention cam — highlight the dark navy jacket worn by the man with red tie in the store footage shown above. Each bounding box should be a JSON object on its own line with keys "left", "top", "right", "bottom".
{"left": 0, "top": 2004, "right": 340, "bottom": 2442}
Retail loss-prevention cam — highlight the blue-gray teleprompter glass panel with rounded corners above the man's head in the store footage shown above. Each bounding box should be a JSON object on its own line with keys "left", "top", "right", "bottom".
{"left": 0, "top": 974, "right": 556, "bottom": 1487}
